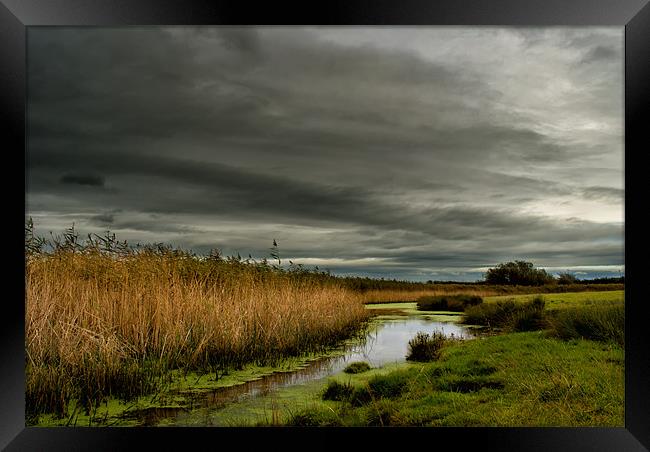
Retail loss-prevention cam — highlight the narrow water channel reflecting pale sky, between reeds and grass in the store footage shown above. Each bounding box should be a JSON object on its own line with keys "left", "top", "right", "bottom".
{"left": 121, "top": 303, "right": 473, "bottom": 426}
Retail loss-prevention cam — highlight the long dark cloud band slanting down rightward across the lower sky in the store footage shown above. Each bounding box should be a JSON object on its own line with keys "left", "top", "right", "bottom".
{"left": 31, "top": 146, "right": 620, "bottom": 251}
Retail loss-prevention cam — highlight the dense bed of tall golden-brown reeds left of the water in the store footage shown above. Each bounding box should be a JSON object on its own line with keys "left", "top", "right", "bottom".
{"left": 25, "top": 250, "right": 367, "bottom": 415}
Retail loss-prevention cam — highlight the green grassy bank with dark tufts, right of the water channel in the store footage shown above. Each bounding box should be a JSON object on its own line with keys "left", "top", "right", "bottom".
{"left": 276, "top": 291, "right": 625, "bottom": 426}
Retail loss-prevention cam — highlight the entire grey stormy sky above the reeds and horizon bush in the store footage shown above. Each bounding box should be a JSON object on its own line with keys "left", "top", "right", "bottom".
{"left": 26, "top": 27, "right": 624, "bottom": 281}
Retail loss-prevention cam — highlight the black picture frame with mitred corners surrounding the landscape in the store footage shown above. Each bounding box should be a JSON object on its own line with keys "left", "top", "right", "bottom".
{"left": 0, "top": 0, "right": 650, "bottom": 451}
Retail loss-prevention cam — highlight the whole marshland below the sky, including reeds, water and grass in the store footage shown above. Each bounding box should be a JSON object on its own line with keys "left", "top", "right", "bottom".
{"left": 25, "top": 220, "right": 624, "bottom": 426}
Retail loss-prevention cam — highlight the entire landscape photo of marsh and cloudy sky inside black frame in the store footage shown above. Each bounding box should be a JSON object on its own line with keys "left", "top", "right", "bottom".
{"left": 25, "top": 26, "right": 631, "bottom": 428}
